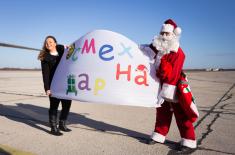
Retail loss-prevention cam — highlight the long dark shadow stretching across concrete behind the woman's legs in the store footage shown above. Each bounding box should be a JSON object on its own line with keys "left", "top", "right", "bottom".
{"left": 0, "top": 103, "right": 149, "bottom": 142}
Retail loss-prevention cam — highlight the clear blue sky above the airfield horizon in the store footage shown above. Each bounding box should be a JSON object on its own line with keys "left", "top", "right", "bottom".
{"left": 0, "top": 0, "right": 235, "bottom": 68}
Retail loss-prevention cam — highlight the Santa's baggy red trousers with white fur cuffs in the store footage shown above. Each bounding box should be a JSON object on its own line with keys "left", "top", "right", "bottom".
{"left": 152, "top": 101, "right": 196, "bottom": 148}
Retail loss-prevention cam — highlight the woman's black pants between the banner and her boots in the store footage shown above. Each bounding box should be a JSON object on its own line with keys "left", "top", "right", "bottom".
{"left": 49, "top": 97, "right": 72, "bottom": 121}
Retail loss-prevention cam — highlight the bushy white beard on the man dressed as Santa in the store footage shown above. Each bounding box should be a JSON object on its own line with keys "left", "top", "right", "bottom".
{"left": 152, "top": 34, "right": 179, "bottom": 55}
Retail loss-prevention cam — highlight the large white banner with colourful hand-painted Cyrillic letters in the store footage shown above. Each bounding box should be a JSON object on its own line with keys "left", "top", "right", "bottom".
{"left": 51, "top": 30, "right": 159, "bottom": 107}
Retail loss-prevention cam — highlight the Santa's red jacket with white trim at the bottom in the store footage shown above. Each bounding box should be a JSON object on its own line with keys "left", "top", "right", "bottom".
{"left": 157, "top": 47, "right": 185, "bottom": 102}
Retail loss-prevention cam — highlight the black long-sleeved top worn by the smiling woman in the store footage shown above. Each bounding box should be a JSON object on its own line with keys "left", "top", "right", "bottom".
{"left": 41, "top": 45, "right": 64, "bottom": 91}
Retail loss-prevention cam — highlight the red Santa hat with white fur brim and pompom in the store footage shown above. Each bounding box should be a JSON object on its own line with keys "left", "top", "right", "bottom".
{"left": 161, "top": 19, "right": 182, "bottom": 36}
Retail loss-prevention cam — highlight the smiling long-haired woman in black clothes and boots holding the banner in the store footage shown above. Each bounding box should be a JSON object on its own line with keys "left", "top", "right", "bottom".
{"left": 38, "top": 36, "right": 72, "bottom": 136}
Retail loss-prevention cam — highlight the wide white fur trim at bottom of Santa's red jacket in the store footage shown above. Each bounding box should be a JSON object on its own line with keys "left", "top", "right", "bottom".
{"left": 160, "top": 83, "right": 176, "bottom": 101}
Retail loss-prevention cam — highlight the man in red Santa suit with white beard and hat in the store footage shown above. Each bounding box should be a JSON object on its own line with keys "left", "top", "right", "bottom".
{"left": 142, "top": 19, "right": 197, "bottom": 151}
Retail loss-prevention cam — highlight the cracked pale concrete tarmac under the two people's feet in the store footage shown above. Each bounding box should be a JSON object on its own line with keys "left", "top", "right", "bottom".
{"left": 0, "top": 71, "right": 235, "bottom": 155}
